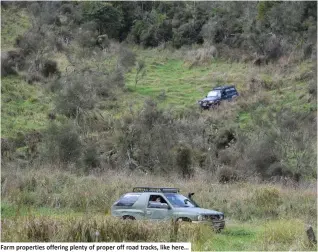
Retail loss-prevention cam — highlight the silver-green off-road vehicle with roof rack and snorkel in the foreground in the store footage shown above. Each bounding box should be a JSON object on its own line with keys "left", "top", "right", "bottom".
{"left": 111, "top": 187, "right": 225, "bottom": 231}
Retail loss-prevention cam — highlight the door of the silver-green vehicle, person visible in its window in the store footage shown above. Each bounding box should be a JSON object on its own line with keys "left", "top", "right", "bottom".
{"left": 146, "top": 194, "right": 171, "bottom": 220}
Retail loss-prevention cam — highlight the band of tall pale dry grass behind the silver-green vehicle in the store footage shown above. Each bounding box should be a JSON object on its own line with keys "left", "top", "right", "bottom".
{"left": 1, "top": 169, "right": 317, "bottom": 225}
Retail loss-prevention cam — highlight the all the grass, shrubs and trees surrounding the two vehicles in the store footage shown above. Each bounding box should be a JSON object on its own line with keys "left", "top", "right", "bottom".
{"left": 1, "top": 1, "right": 317, "bottom": 250}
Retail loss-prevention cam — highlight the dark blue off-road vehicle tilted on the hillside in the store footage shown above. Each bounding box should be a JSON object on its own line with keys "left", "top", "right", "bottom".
{"left": 198, "top": 85, "right": 239, "bottom": 109}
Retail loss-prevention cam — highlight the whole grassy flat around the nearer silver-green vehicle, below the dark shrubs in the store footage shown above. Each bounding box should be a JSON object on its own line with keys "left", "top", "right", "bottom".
{"left": 1, "top": 167, "right": 317, "bottom": 251}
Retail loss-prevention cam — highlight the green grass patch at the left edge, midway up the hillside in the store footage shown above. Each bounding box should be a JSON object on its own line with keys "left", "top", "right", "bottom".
{"left": 1, "top": 76, "right": 51, "bottom": 137}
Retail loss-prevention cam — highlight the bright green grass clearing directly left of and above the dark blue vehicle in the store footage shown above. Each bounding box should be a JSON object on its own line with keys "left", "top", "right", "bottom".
{"left": 126, "top": 59, "right": 251, "bottom": 111}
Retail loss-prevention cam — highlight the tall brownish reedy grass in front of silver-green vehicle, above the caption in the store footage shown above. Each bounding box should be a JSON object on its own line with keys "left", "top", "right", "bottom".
{"left": 1, "top": 216, "right": 213, "bottom": 242}
